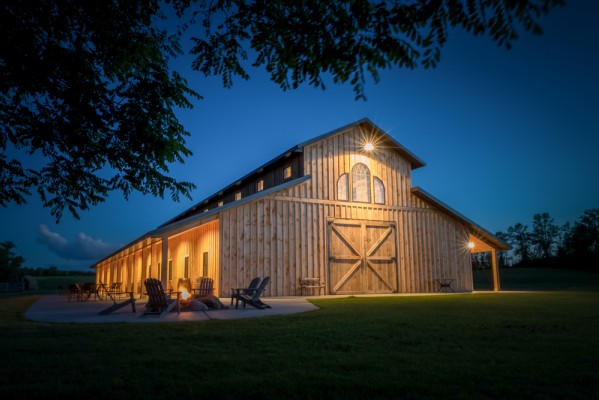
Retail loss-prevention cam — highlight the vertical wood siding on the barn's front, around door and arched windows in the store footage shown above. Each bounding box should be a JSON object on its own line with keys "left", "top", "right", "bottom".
{"left": 219, "top": 128, "right": 472, "bottom": 296}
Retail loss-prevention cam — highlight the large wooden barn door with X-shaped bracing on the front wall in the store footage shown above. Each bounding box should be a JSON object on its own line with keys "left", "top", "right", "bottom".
{"left": 327, "top": 220, "right": 398, "bottom": 294}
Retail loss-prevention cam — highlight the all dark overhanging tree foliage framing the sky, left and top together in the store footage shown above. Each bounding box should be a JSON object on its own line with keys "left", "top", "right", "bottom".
{"left": 0, "top": 0, "right": 563, "bottom": 221}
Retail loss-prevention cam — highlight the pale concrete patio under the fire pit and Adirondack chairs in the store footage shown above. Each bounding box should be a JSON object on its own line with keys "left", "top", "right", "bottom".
{"left": 25, "top": 295, "right": 318, "bottom": 323}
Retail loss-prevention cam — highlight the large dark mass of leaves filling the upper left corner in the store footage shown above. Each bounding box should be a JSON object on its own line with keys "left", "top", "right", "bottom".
{"left": 0, "top": 0, "right": 199, "bottom": 221}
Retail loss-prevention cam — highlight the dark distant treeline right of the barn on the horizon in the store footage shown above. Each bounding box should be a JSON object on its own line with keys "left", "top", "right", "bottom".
{"left": 472, "top": 208, "right": 599, "bottom": 272}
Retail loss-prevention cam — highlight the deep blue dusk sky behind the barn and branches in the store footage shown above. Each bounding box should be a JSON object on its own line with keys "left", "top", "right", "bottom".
{"left": 0, "top": 0, "right": 599, "bottom": 269}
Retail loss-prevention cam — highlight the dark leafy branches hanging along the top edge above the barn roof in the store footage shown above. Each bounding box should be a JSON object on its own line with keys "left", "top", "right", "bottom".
{"left": 186, "top": 0, "right": 563, "bottom": 99}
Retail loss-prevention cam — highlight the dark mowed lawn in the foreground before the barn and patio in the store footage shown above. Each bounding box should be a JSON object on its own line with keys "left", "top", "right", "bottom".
{"left": 0, "top": 291, "right": 599, "bottom": 399}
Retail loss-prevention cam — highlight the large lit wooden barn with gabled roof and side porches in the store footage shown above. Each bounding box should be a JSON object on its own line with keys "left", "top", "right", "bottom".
{"left": 92, "top": 119, "right": 509, "bottom": 297}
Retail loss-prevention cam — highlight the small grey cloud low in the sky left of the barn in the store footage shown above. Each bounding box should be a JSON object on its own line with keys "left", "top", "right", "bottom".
{"left": 36, "top": 224, "right": 118, "bottom": 260}
